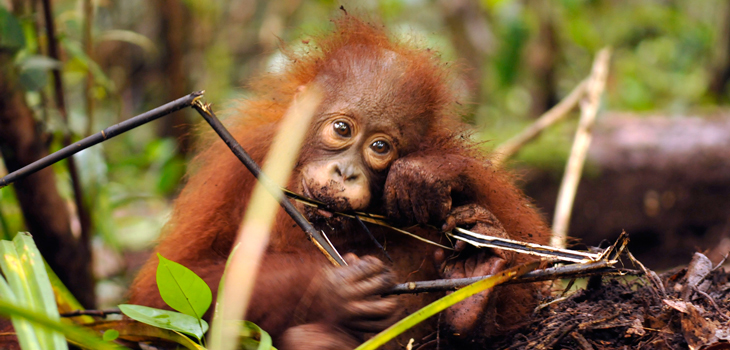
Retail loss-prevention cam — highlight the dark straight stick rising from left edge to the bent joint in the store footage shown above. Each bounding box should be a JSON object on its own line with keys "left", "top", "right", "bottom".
{"left": 0, "top": 91, "right": 203, "bottom": 188}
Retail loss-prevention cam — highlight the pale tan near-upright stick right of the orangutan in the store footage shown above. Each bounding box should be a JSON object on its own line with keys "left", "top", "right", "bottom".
{"left": 550, "top": 48, "right": 611, "bottom": 248}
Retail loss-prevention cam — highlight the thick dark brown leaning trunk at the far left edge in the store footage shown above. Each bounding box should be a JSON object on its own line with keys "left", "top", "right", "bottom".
{"left": 0, "top": 52, "right": 94, "bottom": 307}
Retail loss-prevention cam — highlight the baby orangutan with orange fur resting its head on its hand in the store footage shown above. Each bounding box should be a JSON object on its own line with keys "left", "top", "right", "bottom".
{"left": 130, "top": 14, "right": 549, "bottom": 350}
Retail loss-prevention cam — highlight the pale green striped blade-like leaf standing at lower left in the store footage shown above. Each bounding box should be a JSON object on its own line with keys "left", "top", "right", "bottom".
{"left": 13, "top": 232, "right": 68, "bottom": 349}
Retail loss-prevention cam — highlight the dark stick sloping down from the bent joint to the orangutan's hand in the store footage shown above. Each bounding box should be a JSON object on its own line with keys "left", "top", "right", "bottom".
{"left": 193, "top": 101, "right": 347, "bottom": 266}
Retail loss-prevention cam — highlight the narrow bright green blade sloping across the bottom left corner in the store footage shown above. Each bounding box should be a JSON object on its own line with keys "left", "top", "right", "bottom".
{"left": 0, "top": 298, "right": 121, "bottom": 350}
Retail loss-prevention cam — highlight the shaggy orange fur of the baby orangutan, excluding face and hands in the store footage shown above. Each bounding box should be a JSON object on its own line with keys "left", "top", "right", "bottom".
{"left": 130, "top": 15, "right": 549, "bottom": 348}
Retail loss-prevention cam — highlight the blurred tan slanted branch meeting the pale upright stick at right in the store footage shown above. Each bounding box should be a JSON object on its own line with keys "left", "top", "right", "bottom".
{"left": 492, "top": 80, "right": 587, "bottom": 165}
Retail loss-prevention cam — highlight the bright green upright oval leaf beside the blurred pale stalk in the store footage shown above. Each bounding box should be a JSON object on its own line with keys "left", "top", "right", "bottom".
{"left": 157, "top": 253, "right": 213, "bottom": 319}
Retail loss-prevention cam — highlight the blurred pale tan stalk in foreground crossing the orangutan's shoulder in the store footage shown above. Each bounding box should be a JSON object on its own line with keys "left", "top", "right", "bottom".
{"left": 205, "top": 85, "right": 322, "bottom": 350}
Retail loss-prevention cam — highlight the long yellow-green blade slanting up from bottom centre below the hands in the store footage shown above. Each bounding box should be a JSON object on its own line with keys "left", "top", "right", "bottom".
{"left": 355, "top": 261, "right": 540, "bottom": 350}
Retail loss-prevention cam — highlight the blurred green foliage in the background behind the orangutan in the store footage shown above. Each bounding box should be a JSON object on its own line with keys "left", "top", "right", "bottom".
{"left": 0, "top": 0, "right": 730, "bottom": 306}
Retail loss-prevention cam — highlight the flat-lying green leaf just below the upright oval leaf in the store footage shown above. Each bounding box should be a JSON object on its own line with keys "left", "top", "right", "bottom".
{"left": 119, "top": 304, "right": 208, "bottom": 341}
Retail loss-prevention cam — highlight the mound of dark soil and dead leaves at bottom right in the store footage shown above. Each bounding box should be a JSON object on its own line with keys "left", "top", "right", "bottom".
{"left": 494, "top": 253, "right": 730, "bottom": 350}
